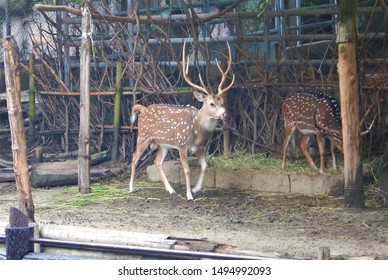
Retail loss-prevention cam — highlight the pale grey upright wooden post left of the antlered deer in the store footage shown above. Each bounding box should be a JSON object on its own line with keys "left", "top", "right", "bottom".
{"left": 78, "top": 1, "right": 91, "bottom": 194}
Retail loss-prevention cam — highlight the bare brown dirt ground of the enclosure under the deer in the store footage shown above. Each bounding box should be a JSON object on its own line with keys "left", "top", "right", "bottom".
{"left": 0, "top": 173, "right": 388, "bottom": 259}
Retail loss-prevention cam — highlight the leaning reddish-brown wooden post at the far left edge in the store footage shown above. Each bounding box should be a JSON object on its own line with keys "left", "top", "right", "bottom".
{"left": 1, "top": 36, "right": 35, "bottom": 221}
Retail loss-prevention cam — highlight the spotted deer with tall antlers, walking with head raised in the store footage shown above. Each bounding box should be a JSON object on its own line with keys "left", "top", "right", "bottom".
{"left": 129, "top": 42, "right": 235, "bottom": 200}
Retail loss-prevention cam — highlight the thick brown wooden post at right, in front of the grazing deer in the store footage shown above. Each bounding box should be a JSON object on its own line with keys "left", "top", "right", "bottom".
{"left": 337, "top": 0, "right": 365, "bottom": 208}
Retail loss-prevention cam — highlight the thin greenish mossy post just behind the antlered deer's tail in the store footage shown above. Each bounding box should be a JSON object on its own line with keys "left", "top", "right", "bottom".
{"left": 112, "top": 61, "right": 123, "bottom": 162}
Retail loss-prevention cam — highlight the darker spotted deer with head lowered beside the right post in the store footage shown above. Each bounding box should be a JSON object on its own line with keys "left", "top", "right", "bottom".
{"left": 282, "top": 91, "right": 342, "bottom": 173}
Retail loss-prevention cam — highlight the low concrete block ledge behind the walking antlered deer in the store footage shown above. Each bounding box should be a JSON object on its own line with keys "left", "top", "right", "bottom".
{"left": 147, "top": 161, "right": 344, "bottom": 196}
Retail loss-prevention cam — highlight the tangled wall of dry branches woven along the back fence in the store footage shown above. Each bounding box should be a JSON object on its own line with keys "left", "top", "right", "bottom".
{"left": 28, "top": 1, "right": 388, "bottom": 160}
